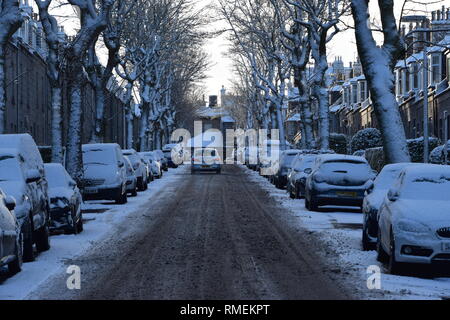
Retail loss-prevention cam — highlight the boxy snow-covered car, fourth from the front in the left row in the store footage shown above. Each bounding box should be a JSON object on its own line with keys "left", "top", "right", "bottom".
{"left": 82, "top": 143, "right": 128, "bottom": 204}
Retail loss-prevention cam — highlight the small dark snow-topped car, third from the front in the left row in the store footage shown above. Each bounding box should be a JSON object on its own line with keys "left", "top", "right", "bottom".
{"left": 44, "top": 163, "right": 83, "bottom": 234}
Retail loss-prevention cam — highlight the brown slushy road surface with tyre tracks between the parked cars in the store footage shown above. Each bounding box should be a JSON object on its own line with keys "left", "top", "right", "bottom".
{"left": 31, "top": 166, "right": 349, "bottom": 300}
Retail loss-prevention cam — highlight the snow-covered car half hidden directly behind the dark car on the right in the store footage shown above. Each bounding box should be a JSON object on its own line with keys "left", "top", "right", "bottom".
{"left": 286, "top": 154, "right": 317, "bottom": 199}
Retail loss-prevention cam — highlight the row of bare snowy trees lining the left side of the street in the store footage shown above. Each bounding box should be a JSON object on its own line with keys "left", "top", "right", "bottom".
{"left": 0, "top": 0, "right": 208, "bottom": 180}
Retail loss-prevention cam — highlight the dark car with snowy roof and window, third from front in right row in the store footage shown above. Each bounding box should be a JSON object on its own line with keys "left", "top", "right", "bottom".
{"left": 305, "top": 154, "right": 376, "bottom": 211}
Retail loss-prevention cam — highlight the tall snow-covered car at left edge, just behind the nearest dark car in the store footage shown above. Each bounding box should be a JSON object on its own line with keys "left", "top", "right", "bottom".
{"left": 0, "top": 134, "right": 50, "bottom": 262}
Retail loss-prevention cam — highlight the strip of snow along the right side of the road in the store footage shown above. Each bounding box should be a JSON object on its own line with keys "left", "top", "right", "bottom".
{"left": 246, "top": 169, "right": 450, "bottom": 300}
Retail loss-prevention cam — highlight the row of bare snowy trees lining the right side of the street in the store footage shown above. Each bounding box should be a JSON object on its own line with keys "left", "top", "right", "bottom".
{"left": 219, "top": 0, "right": 409, "bottom": 162}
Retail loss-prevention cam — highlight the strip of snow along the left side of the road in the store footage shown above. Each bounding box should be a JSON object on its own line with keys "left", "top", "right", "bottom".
{"left": 0, "top": 167, "right": 183, "bottom": 300}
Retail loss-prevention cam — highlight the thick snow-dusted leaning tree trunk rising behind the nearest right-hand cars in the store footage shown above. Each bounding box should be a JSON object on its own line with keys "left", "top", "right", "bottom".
{"left": 352, "top": 0, "right": 411, "bottom": 163}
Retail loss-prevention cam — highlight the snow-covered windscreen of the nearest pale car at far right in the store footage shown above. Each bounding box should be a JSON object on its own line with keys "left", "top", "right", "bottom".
{"left": 400, "top": 176, "right": 450, "bottom": 201}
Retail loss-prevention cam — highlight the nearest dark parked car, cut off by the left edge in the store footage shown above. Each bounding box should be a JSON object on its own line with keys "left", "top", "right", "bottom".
{"left": 0, "top": 189, "right": 23, "bottom": 274}
